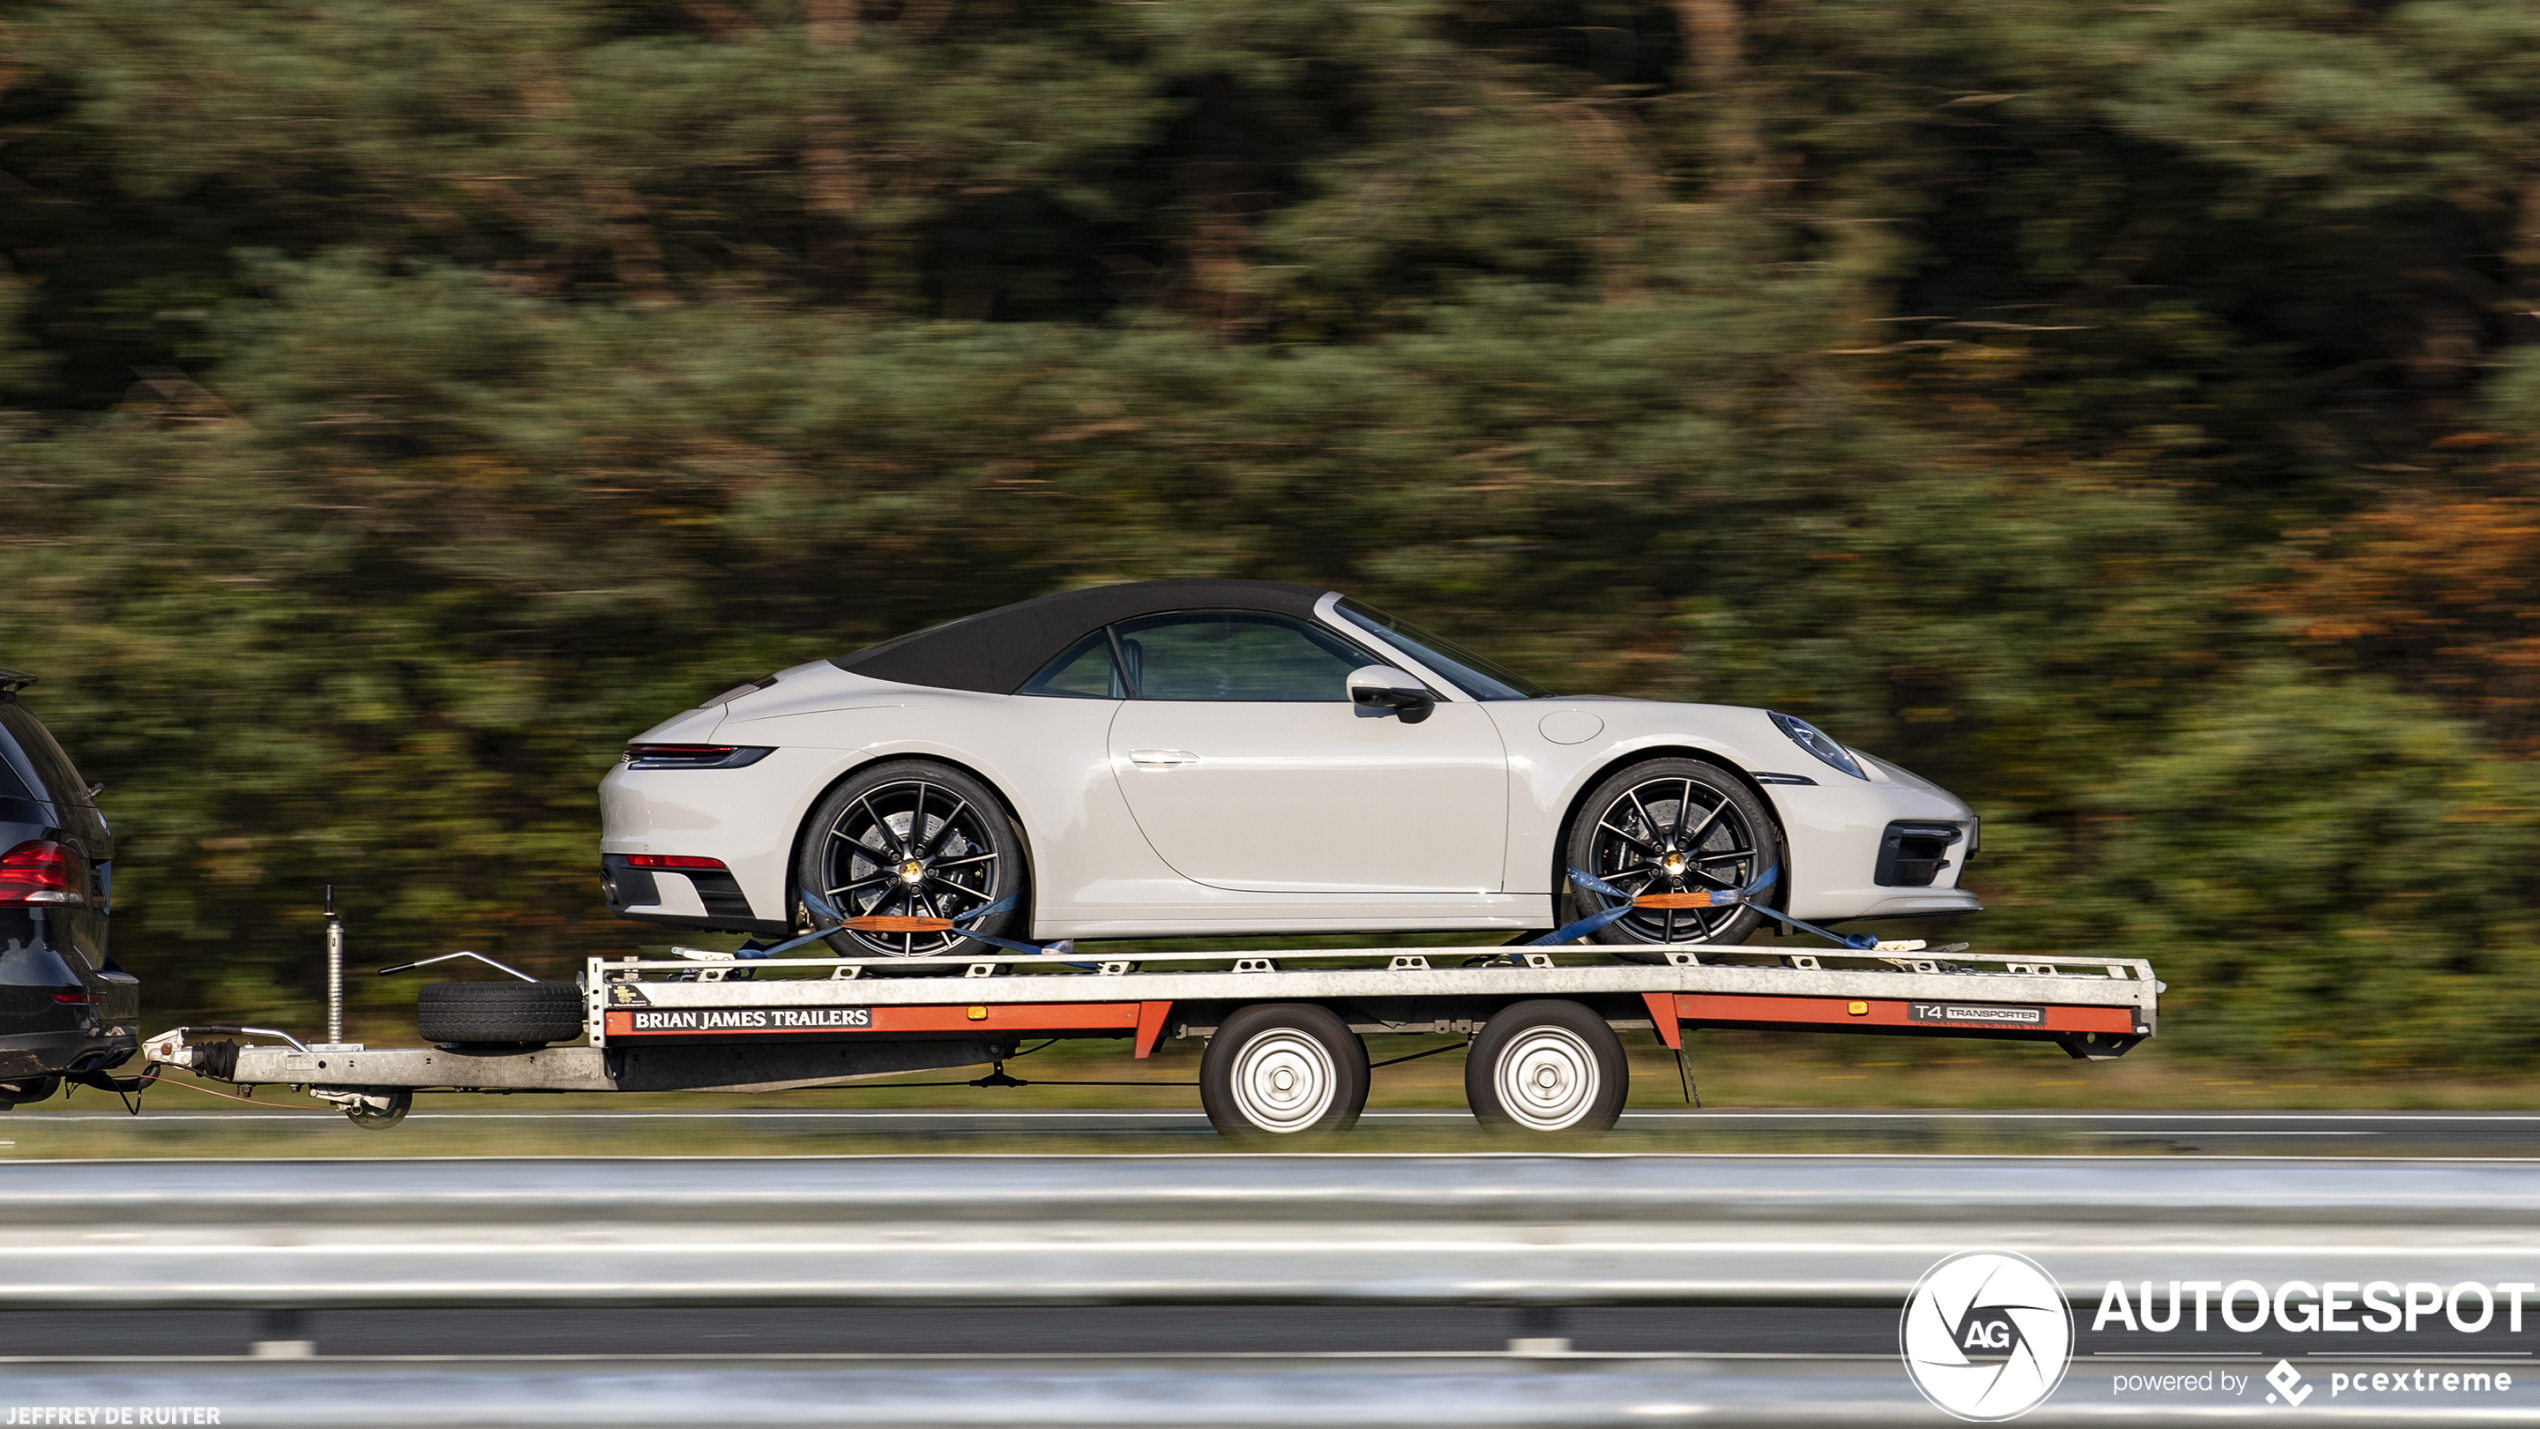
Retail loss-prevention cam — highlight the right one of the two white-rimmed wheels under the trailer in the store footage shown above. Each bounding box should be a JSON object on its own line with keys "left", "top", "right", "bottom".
{"left": 1463, "top": 998, "right": 1631, "bottom": 1140}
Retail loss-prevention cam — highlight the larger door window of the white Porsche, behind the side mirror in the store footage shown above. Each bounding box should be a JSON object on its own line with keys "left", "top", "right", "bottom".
{"left": 1113, "top": 609, "right": 1379, "bottom": 703}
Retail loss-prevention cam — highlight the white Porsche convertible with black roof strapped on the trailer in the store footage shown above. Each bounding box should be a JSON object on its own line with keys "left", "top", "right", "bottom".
{"left": 599, "top": 581, "right": 1979, "bottom": 959}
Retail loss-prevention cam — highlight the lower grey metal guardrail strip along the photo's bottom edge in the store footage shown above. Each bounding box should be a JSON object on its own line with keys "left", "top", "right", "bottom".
{"left": 19, "top": 1355, "right": 2535, "bottom": 1429}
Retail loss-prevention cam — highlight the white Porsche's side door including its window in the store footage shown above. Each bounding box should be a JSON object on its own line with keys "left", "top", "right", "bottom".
{"left": 1110, "top": 609, "right": 1509, "bottom": 893}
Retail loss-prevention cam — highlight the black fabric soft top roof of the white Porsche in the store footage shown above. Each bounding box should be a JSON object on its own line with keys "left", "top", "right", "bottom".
{"left": 831, "top": 581, "right": 1323, "bottom": 695}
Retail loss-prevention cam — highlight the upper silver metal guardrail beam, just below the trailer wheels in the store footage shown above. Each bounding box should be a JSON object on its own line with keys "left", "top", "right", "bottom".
{"left": 14, "top": 1155, "right": 2540, "bottom": 1307}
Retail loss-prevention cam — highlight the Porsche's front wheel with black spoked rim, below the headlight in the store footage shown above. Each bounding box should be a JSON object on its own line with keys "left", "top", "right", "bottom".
{"left": 1562, "top": 759, "right": 1786, "bottom": 962}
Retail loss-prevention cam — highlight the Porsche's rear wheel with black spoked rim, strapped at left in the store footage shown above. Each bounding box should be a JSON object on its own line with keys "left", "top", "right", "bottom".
{"left": 787, "top": 759, "right": 1031, "bottom": 972}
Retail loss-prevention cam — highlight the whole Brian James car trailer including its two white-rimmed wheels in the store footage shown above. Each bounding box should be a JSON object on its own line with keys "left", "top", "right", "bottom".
{"left": 142, "top": 939, "right": 2162, "bottom": 1145}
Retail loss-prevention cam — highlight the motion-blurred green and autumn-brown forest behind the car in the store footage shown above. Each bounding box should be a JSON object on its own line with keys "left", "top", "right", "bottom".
{"left": 0, "top": 0, "right": 2540, "bottom": 1074}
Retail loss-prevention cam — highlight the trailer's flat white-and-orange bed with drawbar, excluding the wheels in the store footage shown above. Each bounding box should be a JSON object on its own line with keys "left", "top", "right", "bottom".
{"left": 145, "top": 944, "right": 2162, "bottom": 1124}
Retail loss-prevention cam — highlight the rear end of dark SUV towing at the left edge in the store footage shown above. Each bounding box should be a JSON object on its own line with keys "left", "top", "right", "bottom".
{"left": 0, "top": 670, "right": 142, "bottom": 1107}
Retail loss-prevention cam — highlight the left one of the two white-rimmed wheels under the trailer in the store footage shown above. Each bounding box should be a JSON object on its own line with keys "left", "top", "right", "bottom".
{"left": 1199, "top": 1003, "right": 1367, "bottom": 1147}
